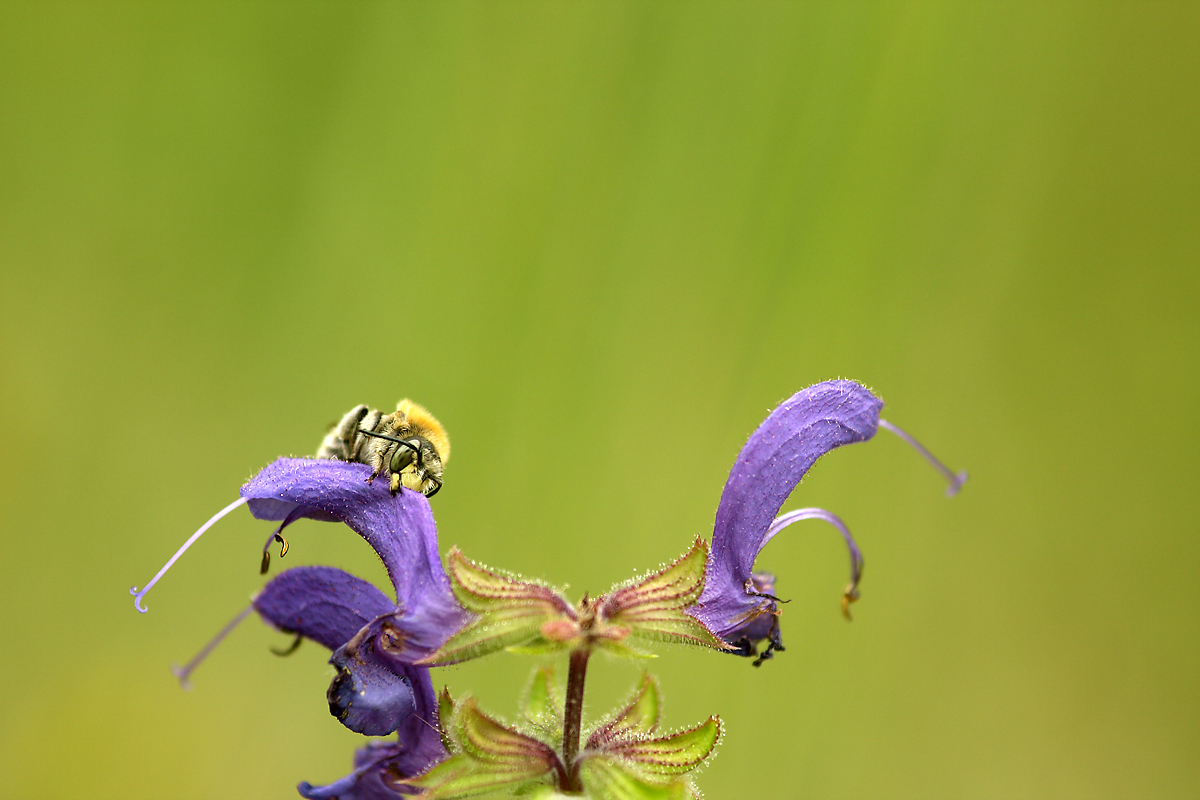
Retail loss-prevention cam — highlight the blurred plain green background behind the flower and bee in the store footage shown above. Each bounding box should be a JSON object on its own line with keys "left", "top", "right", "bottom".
{"left": 0, "top": 2, "right": 1200, "bottom": 798}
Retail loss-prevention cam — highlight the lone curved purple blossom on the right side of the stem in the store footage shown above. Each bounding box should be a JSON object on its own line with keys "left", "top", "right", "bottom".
{"left": 689, "top": 380, "right": 966, "bottom": 666}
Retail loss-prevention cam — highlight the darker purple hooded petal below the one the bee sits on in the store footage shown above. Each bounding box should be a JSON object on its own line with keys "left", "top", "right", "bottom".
{"left": 254, "top": 566, "right": 396, "bottom": 650}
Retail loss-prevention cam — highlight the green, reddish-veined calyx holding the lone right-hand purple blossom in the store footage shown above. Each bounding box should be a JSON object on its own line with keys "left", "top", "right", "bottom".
{"left": 596, "top": 536, "right": 731, "bottom": 650}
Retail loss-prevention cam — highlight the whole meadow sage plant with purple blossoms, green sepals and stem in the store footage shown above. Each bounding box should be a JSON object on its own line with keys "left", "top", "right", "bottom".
{"left": 131, "top": 380, "right": 966, "bottom": 800}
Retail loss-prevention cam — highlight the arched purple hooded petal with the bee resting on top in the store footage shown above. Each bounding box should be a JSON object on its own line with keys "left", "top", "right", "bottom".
{"left": 241, "top": 458, "right": 467, "bottom": 660}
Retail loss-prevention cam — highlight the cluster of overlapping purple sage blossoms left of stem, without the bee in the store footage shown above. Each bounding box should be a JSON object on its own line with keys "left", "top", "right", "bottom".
{"left": 158, "top": 458, "right": 469, "bottom": 800}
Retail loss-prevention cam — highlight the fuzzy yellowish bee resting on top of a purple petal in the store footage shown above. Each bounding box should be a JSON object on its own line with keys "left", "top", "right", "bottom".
{"left": 317, "top": 398, "right": 450, "bottom": 498}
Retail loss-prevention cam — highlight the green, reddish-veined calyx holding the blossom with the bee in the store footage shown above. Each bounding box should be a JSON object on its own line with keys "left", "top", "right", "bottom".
{"left": 418, "top": 547, "right": 578, "bottom": 666}
